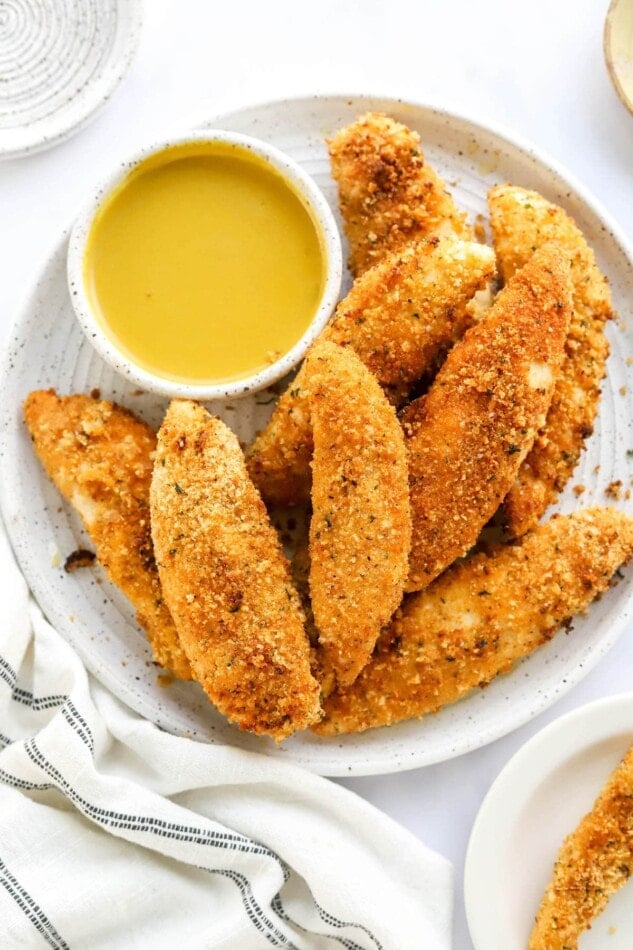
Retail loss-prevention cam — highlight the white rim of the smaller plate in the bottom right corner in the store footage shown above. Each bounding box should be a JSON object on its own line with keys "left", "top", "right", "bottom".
{"left": 463, "top": 691, "right": 633, "bottom": 950}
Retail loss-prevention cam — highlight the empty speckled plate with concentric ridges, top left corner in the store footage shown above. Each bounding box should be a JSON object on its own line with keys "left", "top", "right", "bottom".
{"left": 0, "top": 0, "right": 142, "bottom": 158}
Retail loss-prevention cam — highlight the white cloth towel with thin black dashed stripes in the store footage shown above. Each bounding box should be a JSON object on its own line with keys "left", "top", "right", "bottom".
{"left": 0, "top": 531, "right": 452, "bottom": 950}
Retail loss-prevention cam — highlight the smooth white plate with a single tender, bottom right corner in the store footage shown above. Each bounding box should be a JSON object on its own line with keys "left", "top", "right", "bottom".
{"left": 464, "top": 693, "right": 633, "bottom": 950}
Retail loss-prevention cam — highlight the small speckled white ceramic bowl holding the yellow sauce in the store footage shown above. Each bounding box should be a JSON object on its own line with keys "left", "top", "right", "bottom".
{"left": 68, "top": 130, "right": 343, "bottom": 401}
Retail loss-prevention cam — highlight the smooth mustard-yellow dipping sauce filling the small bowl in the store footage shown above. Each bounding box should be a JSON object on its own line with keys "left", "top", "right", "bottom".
{"left": 84, "top": 142, "right": 325, "bottom": 384}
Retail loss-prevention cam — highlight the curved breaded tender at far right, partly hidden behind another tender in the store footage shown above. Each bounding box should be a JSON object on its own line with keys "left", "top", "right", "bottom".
{"left": 489, "top": 185, "right": 611, "bottom": 537}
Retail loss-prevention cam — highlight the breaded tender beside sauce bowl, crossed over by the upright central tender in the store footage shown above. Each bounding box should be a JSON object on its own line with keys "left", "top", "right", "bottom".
{"left": 247, "top": 238, "right": 495, "bottom": 505}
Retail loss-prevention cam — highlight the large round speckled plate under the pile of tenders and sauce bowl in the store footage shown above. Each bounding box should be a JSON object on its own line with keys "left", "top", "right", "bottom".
{"left": 0, "top": 96, "right": 633, "bottom": 775}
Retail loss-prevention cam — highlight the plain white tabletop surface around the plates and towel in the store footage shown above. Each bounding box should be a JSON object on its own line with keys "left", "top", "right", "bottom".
{"left": 0, "top": 0, "right": 633, "bottom": 950}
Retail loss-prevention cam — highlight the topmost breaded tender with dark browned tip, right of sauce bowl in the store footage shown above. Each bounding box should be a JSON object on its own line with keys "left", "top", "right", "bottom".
{"left": 328, "top": 112, "right": 472, "bottom": 277}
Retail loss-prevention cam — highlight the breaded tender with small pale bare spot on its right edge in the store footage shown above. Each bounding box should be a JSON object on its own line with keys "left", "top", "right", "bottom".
{"left": 402, "top": 245, "right": 571, "bottom": 590}
